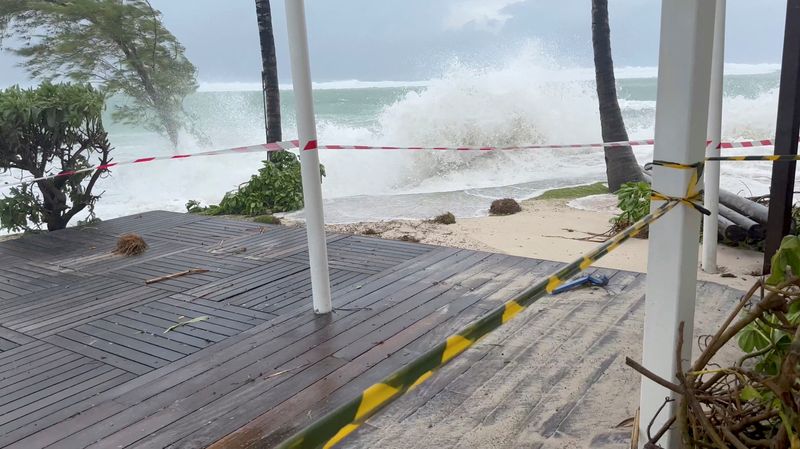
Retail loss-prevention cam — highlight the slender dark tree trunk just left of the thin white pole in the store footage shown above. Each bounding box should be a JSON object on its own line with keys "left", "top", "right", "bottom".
{"left": 256, "top": 0, "right": 282, "bottom": 143}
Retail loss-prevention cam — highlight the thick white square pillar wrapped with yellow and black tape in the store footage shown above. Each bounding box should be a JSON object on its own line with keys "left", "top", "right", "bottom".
{"left": 639, "top": 0, "right": 714, "bottom": 449}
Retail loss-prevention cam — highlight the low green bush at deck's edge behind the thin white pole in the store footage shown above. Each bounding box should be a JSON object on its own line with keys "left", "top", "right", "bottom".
{"left": 186, "top": 151, "right": 325, "bottom": 217}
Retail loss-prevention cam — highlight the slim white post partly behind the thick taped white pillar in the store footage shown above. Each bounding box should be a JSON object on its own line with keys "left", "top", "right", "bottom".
{"left": 700, "top": 0, "right": 726, "bottom": 273}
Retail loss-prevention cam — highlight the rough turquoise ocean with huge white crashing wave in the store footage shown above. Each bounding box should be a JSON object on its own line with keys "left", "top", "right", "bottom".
{"left": 0, "top": 58, "right": 779, "bottom": 228}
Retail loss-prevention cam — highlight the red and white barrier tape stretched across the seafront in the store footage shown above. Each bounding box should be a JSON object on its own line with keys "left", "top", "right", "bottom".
{"left": 0, "top": 139, "right": 774, "bottom": 189}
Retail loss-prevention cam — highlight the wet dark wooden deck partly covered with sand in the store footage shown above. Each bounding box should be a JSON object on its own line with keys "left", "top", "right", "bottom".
{"left": 0, "top": 212, "right": 735, "bottom": 449}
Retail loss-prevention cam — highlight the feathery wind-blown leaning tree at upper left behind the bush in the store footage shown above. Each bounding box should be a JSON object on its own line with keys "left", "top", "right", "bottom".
{"left": 0, "top": 0, "right": 202, "bottom": 145}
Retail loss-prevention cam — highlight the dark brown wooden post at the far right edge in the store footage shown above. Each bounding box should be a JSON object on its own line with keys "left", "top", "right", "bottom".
{"left": 764, "top": 0, "right": 800, "bottom": 273}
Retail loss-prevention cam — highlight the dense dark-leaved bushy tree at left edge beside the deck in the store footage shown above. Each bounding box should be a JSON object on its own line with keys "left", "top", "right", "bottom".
{"left": 0, "top": 82, "right": 111, "bottom": 231}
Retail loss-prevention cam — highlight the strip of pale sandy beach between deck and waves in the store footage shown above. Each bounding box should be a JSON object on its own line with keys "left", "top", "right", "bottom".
{"left": 328, "top": 195, "right": 763, "bottom": 290}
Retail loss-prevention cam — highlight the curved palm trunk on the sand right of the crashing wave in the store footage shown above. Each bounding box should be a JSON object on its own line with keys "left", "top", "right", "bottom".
{"left": 592, "top": 0, "right": 644, "bottom": 192}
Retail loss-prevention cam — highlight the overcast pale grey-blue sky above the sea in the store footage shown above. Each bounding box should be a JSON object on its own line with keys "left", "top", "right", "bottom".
{"left": 0, "top": 0, "right": 786, "bottom": 86}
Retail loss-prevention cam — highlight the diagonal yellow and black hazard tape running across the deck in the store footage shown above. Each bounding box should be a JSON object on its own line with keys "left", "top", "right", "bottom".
{"left": 278, "top": 172, "right": 707, "bottom": 449}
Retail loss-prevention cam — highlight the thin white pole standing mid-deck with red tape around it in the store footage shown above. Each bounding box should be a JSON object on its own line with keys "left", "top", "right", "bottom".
{"left": 286, "top": 0, "right": 332, "bottom": 314}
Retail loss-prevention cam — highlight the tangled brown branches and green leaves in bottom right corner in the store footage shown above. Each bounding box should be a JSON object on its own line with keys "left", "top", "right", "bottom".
{"left": 625, "top": 276, "right": 800, "bottom": 448}
